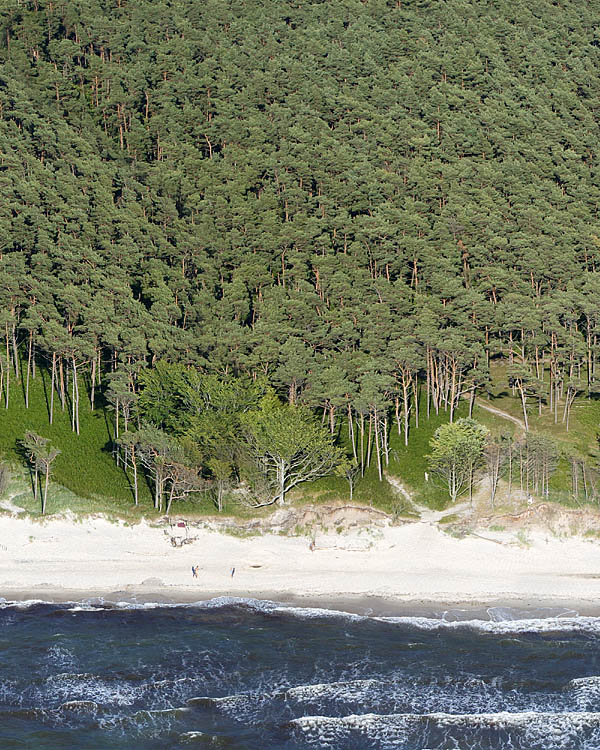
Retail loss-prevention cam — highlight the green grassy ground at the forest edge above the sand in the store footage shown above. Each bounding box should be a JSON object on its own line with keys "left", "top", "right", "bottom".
{"left": 0, "top": 366, "right": 600, "bottom": 517}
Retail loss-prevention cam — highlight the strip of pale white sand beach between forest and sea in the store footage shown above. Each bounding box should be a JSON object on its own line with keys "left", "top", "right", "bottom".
{"left": 0, "top": 515, "right": 600, "bottom": 610}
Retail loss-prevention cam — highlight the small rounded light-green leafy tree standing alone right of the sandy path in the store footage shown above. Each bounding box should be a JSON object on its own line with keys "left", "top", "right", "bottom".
{"left": 427, "top": 419, "right": 488, "bottom": 503}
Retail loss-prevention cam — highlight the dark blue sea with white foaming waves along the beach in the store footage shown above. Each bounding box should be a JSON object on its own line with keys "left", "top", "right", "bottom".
{"left": 0, "top": 600, "right": 600, "bottom": 750}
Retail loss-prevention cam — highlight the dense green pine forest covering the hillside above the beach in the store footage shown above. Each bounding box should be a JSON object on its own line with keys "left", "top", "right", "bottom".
{"left": 0, "top": 0, "right": 600, "bottom": 509}
